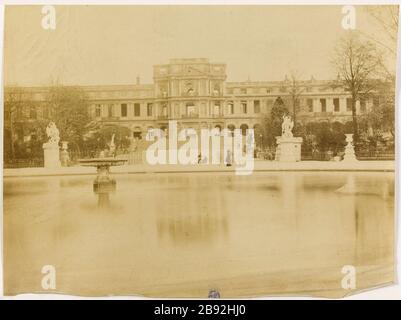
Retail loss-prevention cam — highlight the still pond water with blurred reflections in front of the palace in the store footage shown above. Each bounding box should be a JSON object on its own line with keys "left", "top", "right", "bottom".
{"left": 4, "top": 172, "right": 394, "bottom": 297}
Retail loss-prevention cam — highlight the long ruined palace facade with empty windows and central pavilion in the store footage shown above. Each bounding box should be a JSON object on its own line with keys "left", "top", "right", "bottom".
{"left": 6, "top": 58, "right": 374, "bottom": 138}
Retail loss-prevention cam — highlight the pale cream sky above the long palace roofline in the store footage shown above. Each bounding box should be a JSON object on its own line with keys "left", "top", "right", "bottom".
{"left": 4, "top": 6, "right": 396, "bottom": 85}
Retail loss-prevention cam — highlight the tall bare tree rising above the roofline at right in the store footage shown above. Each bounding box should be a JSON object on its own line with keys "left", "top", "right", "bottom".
{"left": 332, "top": 32, "right": 381, "bottom": 139}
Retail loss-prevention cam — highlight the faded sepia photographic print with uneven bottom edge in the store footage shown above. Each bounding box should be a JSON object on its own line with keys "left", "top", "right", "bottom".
{"left": 2, "top": 3, "right": 399, "bottom": 300}
